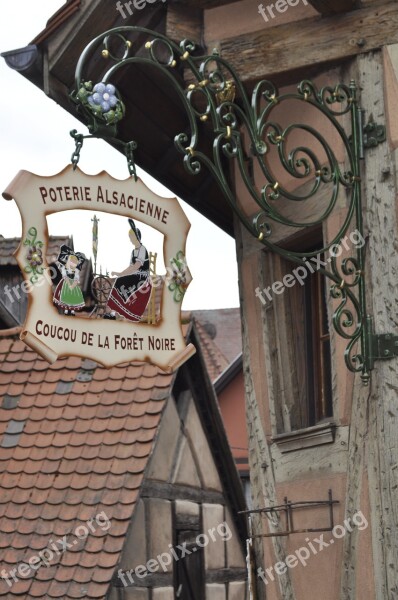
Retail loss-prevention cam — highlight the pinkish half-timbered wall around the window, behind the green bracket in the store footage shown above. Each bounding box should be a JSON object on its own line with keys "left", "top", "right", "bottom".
{"left": 236, "top": 50, "right": 398, "bottom": 600}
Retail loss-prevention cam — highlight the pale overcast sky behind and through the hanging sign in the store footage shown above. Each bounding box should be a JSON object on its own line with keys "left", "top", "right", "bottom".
{"left": 0, "top": 0, "right": 239, "bottom": 310}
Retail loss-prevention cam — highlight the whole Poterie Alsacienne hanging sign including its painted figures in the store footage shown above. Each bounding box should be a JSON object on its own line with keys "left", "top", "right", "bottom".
{"left": 3, "top": 165, "right": 195, "bottom": 371}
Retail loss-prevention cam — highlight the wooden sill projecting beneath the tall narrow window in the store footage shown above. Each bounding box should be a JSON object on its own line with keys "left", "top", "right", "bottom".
{"left": 272, "top": 422, "right": 336, "bottom": 454}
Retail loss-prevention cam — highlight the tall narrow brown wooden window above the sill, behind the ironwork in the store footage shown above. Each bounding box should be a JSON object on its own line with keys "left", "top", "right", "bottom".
{"left": 265, "top": 241, "right": 333, "bottom": 433}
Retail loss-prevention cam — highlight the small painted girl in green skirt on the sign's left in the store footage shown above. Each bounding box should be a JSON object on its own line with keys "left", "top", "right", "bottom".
{"left": 53, "top": 244, "right": 86, "bottom": 316}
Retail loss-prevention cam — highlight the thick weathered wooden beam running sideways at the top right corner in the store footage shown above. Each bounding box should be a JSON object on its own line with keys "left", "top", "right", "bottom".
{"left": 220, "top": 2, "right": 398, "bottom": 82}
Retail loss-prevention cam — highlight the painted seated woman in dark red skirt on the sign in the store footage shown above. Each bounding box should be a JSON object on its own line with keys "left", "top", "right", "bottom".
{"left": 104, "top": 219, "right": 152, "bottom": 321}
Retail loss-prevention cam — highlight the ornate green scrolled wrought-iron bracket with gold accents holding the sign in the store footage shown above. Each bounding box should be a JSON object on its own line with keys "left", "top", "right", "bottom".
{"left": 68, "top": 26, "right": 383, "bottom": 383}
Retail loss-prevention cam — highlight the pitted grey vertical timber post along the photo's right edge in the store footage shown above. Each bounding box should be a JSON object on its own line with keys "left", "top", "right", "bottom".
{"left": 356, "top": 49, "right": 398, "bottom": 599}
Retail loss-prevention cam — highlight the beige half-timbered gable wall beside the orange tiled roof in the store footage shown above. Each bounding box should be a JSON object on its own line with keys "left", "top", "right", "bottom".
{"left": 112, "top": 392, "right": 246, "bottom": 600}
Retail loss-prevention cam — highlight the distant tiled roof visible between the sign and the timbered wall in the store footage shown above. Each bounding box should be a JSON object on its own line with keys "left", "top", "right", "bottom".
{"left": 191, "top": 308, "right": 242, "bottom": 364}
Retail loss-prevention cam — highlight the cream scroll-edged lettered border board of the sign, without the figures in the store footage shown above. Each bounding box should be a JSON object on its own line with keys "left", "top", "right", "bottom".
{"left": 3, "top": 165, "right": 195, "bottom": 371}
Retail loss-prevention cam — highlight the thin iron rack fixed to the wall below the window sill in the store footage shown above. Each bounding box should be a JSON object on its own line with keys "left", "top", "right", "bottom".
{"left": 240, "top": 489, "right": 339, "bottom": 539}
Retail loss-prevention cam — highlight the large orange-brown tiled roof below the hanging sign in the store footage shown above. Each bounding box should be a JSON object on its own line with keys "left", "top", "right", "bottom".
{"left": 0, "top": 331, "right": 172, "bottom": 600}
